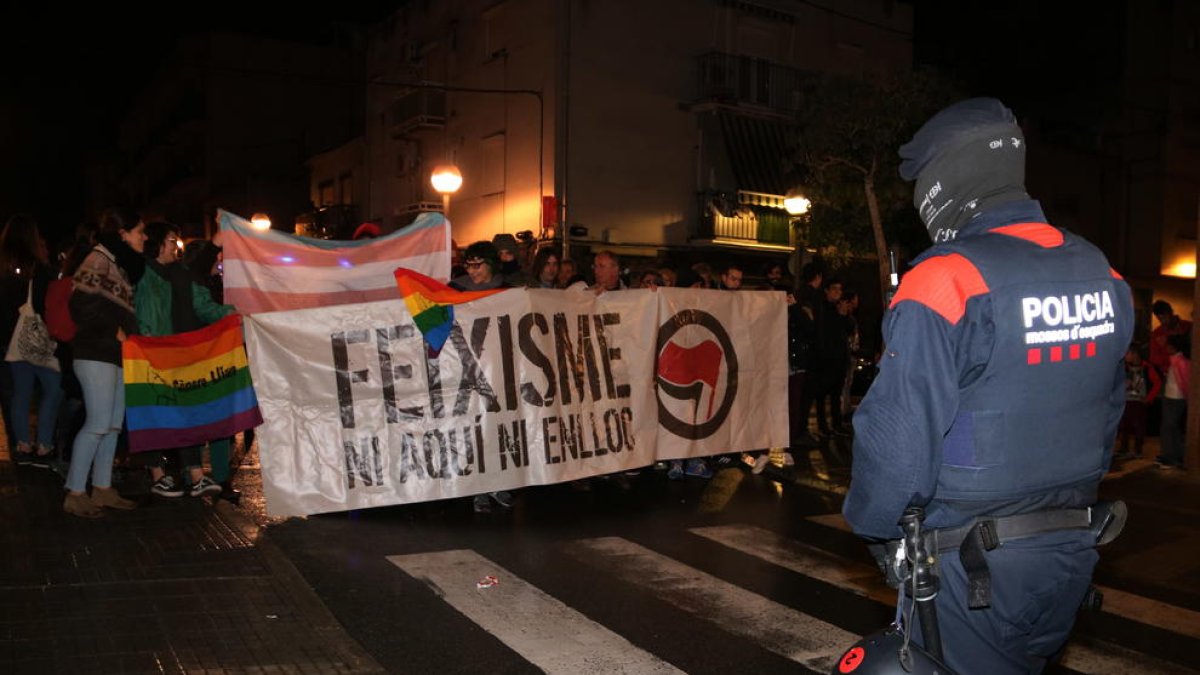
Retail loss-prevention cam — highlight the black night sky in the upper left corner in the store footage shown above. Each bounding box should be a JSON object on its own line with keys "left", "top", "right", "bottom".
{"left": 0, "top": 1, "right": 397, "bottom": 237}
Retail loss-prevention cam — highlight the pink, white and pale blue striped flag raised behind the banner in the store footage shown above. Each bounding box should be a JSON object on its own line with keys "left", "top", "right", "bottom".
{"left": 218, "top": 211, "right": 450, "bottom": 313}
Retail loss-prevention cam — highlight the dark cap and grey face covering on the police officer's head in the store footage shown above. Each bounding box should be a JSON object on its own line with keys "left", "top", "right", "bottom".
{"left": 900, "top": 98, "right": 1028, "bottom": 244}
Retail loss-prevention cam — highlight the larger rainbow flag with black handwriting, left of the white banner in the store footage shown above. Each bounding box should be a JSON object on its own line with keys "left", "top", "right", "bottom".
{"left": 121, "top": 315, "right": 263, "bottom": 453}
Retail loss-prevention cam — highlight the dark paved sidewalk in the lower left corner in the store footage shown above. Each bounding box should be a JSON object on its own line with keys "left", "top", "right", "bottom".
{"left": 0, "top": 450, "right": 383, "bottom": 674}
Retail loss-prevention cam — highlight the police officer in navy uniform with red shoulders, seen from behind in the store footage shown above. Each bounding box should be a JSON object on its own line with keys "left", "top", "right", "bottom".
{"left": 842, "top": 98, "right": 1133, "bottom": 674}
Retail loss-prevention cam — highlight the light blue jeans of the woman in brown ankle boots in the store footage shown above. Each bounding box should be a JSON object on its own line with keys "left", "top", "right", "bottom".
{"left": 66, "top": 359, "right": 125, "bottom": 492}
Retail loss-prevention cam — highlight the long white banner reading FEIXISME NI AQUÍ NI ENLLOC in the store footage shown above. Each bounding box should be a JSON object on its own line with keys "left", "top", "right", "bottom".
{"left": 246, "top": 284, "right": 787, "bottom": 515}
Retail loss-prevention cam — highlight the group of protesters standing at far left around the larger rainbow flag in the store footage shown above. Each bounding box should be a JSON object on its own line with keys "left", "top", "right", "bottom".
{"left": 0, "top": 209, "right": 236, "bottom": 519}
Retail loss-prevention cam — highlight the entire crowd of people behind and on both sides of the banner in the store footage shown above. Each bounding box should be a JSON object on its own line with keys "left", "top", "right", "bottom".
{"left": 7, "top": 209, "right": 1192, "bottom": 518}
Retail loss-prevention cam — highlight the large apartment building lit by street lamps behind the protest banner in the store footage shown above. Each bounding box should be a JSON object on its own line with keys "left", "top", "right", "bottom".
{"left": 358, "top": 0, "right": 912, "bottom": 256}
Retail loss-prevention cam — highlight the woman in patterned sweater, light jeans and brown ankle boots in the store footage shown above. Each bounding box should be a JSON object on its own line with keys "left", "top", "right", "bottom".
{"left": 62, "top": 209, "right": 146, "bottom": 518}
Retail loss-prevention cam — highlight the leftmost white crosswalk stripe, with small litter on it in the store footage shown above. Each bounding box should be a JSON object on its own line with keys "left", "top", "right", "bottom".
{"left": 388, "top": 550, "right": 680, "bottom": 675}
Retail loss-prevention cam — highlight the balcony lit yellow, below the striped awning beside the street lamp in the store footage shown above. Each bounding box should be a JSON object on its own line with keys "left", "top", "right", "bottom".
{"left": 697, "top": 190, "right": 793, "bottom": 250}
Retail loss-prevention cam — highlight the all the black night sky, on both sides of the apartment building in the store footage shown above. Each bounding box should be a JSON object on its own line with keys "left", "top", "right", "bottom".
{"left": 0, "top": 0, "right": 1137, "bottom": 239}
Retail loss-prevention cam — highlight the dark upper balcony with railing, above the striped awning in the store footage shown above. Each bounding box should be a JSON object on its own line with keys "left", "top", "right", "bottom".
{"left": 697, "top": 52, "right": 814, "bottom": 114}
